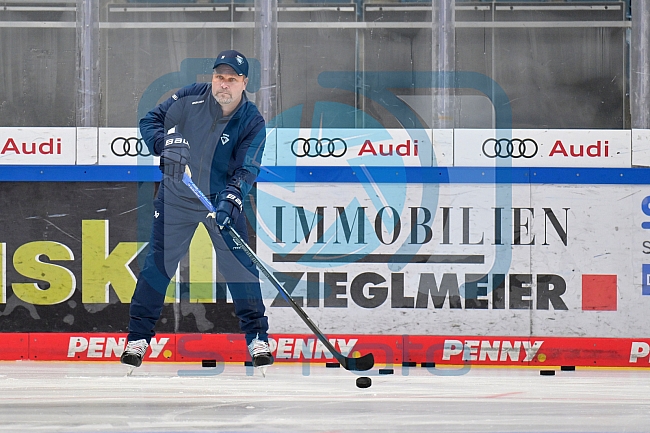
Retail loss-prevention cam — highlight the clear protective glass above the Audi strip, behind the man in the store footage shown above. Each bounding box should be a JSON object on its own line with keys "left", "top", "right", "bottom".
{"left": 0, "top": 0, "right": 630, "bottom": 129}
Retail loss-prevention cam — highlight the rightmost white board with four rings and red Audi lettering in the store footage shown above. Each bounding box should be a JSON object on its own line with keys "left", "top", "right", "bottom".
{"left": 454, "top": 129, "right": 632, "bottom": 167}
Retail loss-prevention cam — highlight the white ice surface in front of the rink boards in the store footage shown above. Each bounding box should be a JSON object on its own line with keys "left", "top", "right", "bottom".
{"left": 0, "top": 361, "right": 650, "bottom": 433}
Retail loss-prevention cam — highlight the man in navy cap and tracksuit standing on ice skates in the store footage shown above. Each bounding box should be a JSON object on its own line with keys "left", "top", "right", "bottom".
{"left": 120, "top": 50, "right": 273, "bottom": 367}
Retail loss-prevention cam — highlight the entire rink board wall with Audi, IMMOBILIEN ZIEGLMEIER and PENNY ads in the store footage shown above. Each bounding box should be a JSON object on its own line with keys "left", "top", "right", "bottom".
{"left": 0, "top": 128, "right": 650, "bottom": 367}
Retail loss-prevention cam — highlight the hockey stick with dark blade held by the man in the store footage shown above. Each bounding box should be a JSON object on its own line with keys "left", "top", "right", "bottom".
{"left": 183, "top": 173, "right": 375, "bottom": 371}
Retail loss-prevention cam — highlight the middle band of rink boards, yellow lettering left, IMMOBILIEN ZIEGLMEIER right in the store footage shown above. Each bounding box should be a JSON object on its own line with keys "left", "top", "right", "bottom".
{"left": 0, "top": 182, "right": 650, "bottom": 338}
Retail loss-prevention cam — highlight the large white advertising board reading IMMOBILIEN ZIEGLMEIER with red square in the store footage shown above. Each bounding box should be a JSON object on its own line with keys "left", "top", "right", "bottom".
{"left": 257, "top": 183, "right": 650, "bottom": 337}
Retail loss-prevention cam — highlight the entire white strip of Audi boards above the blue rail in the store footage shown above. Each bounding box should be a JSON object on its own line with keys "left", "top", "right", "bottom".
{"left": 0, "top": 127, "right": 632, "bottom": 168}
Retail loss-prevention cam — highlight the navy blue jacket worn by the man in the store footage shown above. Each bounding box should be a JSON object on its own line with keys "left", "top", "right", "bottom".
{"left": 140, "top": 83, "right": 266, "bottom": 203}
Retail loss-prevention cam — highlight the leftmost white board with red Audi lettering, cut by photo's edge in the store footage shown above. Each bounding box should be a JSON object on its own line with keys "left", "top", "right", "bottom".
{"left": 0, "top": 127, "right": 76, "bottom": 165}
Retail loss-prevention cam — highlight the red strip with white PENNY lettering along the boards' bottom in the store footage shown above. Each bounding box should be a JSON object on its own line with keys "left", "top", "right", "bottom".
{"left": 0, "top": 333, "right": 650, "bottom": 368}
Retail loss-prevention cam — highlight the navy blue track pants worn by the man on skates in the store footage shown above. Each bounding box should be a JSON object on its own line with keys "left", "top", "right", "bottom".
{"left": 128, "top": 191, "right": 268, "bottom": 344}
